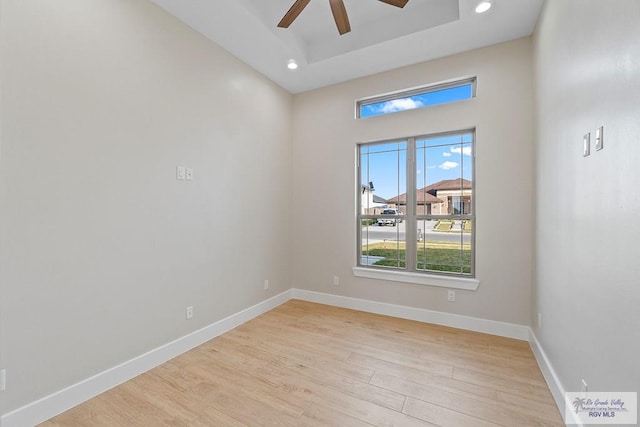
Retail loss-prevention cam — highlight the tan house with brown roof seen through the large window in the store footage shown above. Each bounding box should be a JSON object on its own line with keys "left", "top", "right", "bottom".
{"left": 387, "top": 178, "right": 473, "bottom": 215}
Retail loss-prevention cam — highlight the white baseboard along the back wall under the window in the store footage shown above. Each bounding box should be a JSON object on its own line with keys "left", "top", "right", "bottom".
{"left": 293, "top": 289, "right": 529, "bottom": 341}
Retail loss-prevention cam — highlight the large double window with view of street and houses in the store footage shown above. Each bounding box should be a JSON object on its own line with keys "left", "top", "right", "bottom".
{"left": 354, "top": 130, "right": 477, "bottom": 289}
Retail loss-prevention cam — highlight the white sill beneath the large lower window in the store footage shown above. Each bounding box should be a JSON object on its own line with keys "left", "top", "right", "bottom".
{"left": 353, "top": 267, "right": 480, "bottom": 291}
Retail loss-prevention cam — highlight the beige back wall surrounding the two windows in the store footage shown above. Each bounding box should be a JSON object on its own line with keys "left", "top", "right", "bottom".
{"left": 292, "top": 38, "right": 533, "bottom": 325}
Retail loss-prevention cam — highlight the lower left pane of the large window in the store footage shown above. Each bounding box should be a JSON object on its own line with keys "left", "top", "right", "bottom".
{"left": 361, "top": 219, "right": 406, "bottom": 269}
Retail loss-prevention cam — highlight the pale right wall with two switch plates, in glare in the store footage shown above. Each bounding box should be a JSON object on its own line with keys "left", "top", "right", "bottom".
{"left": 532, "top": 0, "right": 640, "bottom": 398}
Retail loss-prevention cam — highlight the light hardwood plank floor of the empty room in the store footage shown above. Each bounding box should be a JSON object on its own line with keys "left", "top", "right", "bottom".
{"left": 42, "top": 300, "right": 564, "bottom": 427}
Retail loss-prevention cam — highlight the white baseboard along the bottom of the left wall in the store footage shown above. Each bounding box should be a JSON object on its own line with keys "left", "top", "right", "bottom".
{"left": 0, "top": 289, "right": 292, "bottom": 427}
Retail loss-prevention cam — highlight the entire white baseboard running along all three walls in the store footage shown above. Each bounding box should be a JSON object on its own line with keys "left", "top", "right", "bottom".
{"left": 0, "top": 288, "right": 564, "bottom": 427}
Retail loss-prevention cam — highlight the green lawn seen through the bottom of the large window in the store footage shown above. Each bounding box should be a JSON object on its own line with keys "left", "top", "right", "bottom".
{"left": 362, "top": 241, "right": 471, "bottom": 274}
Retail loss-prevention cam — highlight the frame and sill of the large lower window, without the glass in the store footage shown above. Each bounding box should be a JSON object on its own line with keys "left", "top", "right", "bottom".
{"left": 353, "top": 128, "right": 480, "bottom": 290}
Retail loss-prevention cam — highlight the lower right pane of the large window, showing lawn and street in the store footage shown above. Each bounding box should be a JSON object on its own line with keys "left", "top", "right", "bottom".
{"left": 416, "top": 219, "right": 472, "bottom": 275}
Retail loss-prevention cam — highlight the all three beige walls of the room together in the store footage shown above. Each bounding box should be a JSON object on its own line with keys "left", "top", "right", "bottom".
{"left": 7, "top": 0, "right": 640, "bottom": 422}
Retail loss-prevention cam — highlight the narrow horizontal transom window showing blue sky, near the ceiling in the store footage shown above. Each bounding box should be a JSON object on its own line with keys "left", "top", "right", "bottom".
{"left": 356, "top": 77, "right": 476, "bottom": 118}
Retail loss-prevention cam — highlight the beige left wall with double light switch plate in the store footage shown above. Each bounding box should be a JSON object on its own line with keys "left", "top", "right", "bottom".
{"left": 0, "top": 0, "right": 292, "bottom": 413}
